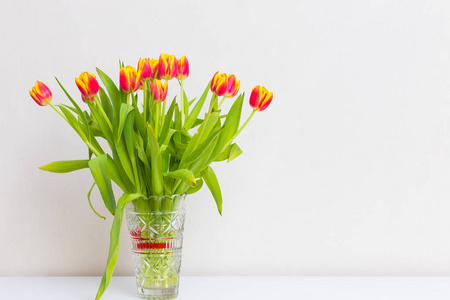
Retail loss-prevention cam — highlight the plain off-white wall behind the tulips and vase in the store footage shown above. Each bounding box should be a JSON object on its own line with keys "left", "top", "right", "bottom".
{"left": 0, "top": 0, "right": 450, "bottom": 276}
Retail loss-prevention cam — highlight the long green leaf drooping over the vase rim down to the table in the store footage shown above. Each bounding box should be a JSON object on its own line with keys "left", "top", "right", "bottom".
{"left": 95, "top": 193, "right": 143, "bottom": 300}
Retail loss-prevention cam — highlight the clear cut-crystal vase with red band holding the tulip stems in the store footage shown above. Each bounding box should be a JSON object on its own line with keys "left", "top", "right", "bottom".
{"left": 126, "top": 194, "right": 186, "bottom": 299}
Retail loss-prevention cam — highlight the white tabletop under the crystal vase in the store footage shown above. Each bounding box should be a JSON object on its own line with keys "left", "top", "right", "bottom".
{"left": 0, "top": 276, "right": 450, "bottom": 300}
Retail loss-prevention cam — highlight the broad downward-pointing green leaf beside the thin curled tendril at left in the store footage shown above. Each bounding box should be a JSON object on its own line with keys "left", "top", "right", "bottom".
{"left": 89, "top": 154, "right": 116, "bottom": 215}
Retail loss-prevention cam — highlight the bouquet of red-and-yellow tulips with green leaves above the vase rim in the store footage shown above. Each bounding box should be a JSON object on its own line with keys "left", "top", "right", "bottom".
{"left": 30, "top": 54, "right": 273, "bottom": 299}
